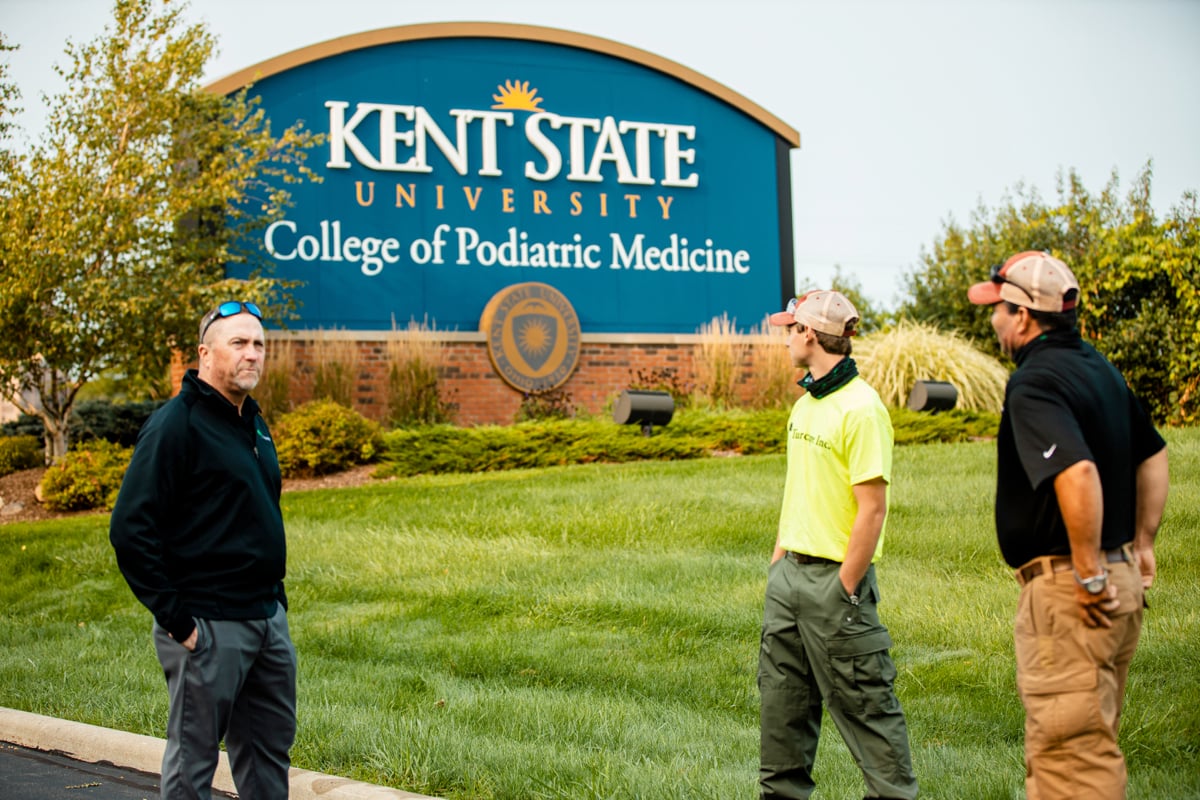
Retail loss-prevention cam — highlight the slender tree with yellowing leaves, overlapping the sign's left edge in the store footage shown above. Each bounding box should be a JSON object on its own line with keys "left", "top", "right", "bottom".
{"left": 0, "top": 0, "right": 319, "bottom": 461}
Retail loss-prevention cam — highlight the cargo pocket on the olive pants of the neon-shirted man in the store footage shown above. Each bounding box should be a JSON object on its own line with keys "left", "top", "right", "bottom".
{"left": 827, "top": 626, "right": 900, "bottom": 717}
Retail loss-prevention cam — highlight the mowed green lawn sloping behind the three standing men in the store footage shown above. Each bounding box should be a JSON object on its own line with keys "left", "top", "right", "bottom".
{"left": 0, "top": 429, "right": 1200, "bottom": 800}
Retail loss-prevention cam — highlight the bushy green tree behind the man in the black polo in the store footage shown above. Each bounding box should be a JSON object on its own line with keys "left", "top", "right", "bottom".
{"left": 899, "top": 163, "right": 1200, "bottom": 423}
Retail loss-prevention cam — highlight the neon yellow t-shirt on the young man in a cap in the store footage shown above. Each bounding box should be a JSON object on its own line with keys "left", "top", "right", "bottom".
{"left": 779, "top": 378, "right": 893, "bottom": 561}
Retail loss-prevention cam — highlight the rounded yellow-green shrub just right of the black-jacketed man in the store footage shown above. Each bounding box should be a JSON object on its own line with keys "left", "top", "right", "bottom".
{"left": 275, "top": 401, "right": 383, "bottom": 477}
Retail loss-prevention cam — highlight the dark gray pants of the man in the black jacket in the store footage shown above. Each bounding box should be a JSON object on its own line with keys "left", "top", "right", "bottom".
{"left": 154, "top": 606, "right": 296, "bottom": 800}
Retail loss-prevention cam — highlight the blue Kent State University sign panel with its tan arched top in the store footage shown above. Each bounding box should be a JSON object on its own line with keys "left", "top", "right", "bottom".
{"left": 210, "top": 24, "right": 798, "bottom": 333}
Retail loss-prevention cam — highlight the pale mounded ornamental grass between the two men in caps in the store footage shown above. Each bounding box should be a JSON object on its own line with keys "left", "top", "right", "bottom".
{"left": 854, "top": 320, "right": 1009, "bottom": 414}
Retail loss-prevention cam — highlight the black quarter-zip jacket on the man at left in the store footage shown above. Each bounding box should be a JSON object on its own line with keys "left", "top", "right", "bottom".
{"left": 109, "top": 369, "right": 287, "bottom": 642}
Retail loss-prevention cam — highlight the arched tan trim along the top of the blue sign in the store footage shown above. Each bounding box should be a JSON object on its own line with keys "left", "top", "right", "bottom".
{"left": 208, "top": 23, "right": 800, "bottom": 148}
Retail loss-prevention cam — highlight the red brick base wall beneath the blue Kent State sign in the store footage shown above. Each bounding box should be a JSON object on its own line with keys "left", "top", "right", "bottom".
{"left": 172, "top": 331, "right": 784, "bottom": 426}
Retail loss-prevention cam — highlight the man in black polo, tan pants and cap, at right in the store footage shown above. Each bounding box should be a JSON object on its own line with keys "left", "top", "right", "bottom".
{"left": 967, "top": 252, "right": 1168, "bottom": 800}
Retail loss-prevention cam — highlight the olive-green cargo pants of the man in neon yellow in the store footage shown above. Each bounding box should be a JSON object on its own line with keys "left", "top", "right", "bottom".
{"left": 758, "top": 558, "right": 917, "bottom": 800}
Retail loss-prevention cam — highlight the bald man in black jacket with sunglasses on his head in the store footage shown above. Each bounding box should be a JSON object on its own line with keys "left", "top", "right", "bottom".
{"left": 109, "top": 302, "right": 296, "bottom": 800}
